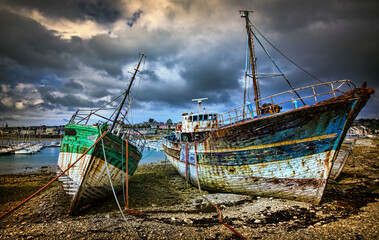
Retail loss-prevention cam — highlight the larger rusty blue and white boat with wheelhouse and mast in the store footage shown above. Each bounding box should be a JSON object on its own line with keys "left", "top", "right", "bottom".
{"left": 163, "top": 11, "right": 374, "bottom": 204}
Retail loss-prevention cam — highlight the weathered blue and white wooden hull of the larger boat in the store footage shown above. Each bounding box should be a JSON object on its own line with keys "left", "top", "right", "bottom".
{"left": 163, "top": 88, "right": 372, "bottom": 204}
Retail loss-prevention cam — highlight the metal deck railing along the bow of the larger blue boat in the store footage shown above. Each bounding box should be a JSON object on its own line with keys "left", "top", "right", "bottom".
{"left": 217, "top": 80, "right": 355, "bottom": 127}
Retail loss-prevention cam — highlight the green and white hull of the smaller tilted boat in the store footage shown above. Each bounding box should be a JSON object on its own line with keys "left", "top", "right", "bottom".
{"left": 58, "top": 123, "right": 142, "bottom": 214}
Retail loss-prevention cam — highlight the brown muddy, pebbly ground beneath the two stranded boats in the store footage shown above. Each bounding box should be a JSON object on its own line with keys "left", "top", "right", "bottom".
{"left": 0, "top": 139, "right": 379, "bottom": 239}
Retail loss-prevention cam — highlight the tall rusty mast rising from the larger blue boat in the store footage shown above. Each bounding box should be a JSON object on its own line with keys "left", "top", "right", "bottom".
{"left": 240, "top": 10, "right": 260, "bottom": 116}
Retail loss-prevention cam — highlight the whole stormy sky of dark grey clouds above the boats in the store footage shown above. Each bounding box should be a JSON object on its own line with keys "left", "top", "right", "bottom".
{"left": 0, "top": 0, "right": 379, "bottom": 126}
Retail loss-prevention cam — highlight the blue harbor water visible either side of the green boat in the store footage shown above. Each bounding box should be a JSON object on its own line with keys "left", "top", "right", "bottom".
{"left": 0, "top": 144, "right": 165, "bottom": 174}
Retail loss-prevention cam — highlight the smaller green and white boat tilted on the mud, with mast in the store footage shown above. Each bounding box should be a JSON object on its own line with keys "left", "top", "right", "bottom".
{"left": 58, "top": 54, "right": 144, "bottom": 214}
